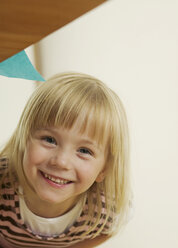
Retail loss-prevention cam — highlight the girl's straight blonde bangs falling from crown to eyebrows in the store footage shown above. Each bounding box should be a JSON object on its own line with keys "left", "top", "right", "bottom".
{"left": 29, "top": 75, "right": 112, "bottom": 144}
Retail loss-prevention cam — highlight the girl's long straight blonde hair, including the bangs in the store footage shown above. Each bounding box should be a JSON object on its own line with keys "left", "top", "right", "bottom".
{"left": 0, "top": 73, "right": 130, "bottom": 236}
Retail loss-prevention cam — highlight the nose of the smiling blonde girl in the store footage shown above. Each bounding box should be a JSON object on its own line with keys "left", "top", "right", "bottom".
{"left": 50, "top": 150, "right": 71, "bottom": 170}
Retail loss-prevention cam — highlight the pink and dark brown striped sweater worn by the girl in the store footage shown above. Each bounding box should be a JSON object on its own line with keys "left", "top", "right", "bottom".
{"left": 0, "top": 162, "right": 112, "bottom": 248}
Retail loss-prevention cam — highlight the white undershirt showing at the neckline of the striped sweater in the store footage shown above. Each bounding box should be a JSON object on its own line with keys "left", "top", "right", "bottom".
{"left": 20, "top": 188, "right": 86, "bottom": 236}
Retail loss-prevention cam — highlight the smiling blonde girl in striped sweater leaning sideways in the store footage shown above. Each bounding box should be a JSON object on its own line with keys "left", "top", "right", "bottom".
{"left": 0, "top": 73, "right": 130, "bottom": 248}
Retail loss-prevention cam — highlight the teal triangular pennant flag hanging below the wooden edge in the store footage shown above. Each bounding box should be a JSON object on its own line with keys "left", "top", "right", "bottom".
{"left": 0, "top": 51, "right": 45, "bottom": 81}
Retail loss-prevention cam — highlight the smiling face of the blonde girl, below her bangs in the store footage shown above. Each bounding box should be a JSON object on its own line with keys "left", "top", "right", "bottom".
{"left": 23, "top": 126, "right": 107, "bottom": 215}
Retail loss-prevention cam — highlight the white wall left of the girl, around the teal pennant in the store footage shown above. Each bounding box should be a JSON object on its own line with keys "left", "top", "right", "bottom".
{"left": 0, "top": 46, "right": 35, "bottom": 148}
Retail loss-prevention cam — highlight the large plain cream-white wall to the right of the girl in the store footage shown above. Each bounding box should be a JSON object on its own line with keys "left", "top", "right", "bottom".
{"left": 35, "top": 0, "right": 178, "bottom": 248}
